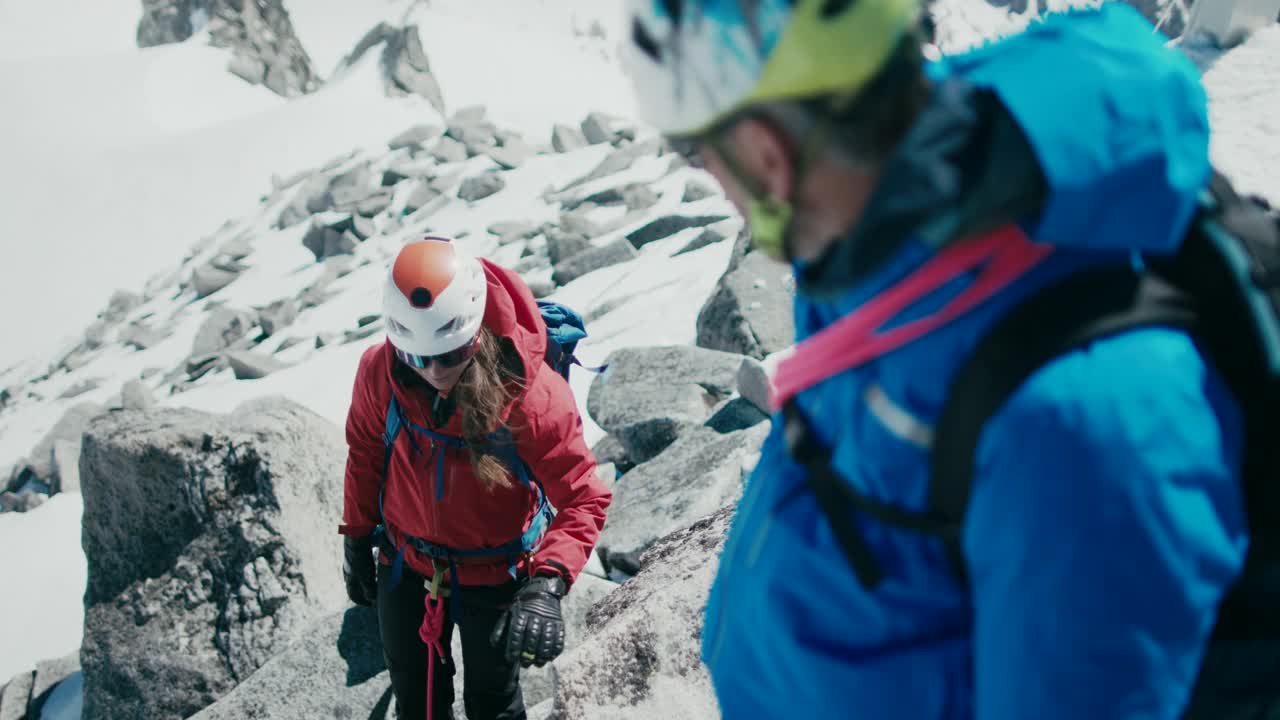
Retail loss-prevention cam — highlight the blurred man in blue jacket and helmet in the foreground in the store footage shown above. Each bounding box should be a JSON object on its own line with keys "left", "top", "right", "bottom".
{"left": 614, "top": 0, "right": 1264, "bottom": 720}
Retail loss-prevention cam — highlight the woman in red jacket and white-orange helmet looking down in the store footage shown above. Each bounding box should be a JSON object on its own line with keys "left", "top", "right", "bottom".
{"left": 340, "top": 238, "right": 612, "bottom": 720}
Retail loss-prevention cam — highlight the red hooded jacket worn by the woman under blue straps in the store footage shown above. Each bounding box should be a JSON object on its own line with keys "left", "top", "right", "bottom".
{"left": 339, "top": 260, "right": 612, "bottom": 584}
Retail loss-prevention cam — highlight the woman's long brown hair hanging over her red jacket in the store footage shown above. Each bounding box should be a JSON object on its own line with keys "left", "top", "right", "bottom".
{"left": 451, "top": 327, "right": 524, "bottom": 491}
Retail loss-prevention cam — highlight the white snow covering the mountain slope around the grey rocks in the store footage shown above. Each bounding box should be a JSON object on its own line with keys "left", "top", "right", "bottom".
{"left": 0, "top": 0, "right": 1280, "bottom": 716}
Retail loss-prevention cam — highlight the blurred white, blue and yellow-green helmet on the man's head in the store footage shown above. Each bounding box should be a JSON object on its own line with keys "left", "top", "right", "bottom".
{"left": 622, "top": 0, "right": 919, "bottom": 137}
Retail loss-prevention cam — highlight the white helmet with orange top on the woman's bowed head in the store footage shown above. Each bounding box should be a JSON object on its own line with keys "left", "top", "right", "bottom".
{"left": 383, "top": 237, "right": 486, "bottom": 368}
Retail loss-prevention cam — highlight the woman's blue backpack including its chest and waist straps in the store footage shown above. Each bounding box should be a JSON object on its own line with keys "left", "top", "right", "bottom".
{"left": 374, "top": 300, "right": 604, "bottom": 604}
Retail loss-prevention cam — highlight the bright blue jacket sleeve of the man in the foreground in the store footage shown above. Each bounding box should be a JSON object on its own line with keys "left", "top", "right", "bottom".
{"left": 964, "top": 329, "right": 1248, "bottom": 720}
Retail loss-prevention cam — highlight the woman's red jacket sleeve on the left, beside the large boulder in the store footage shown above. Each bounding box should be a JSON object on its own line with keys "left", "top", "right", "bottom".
{"left": 338, "top": 346, "right": 387, "bottom": 537}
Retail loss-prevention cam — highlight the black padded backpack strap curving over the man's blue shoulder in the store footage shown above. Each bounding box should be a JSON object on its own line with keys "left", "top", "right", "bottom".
{"left": 928, "top": 268, "right": 1198, "bottom": 582}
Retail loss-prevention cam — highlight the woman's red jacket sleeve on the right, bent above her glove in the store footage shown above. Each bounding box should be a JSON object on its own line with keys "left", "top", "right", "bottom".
{"left": 513, "top": 365, "right": 613, "bottom": 583}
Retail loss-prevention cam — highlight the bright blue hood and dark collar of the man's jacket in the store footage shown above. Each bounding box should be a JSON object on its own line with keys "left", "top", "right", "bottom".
{"left": 796, "top": 3, "right": 1211, "bottom": 296}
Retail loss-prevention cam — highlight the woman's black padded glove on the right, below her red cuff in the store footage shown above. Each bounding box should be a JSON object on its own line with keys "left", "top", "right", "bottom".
{"left": 489, "top": 575, "right": 568, "bottom": 667}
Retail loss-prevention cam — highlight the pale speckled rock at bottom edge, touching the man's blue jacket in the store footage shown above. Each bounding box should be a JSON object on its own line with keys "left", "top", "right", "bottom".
{"left": 552, "top": 509, "right": 732, "bottom": 720}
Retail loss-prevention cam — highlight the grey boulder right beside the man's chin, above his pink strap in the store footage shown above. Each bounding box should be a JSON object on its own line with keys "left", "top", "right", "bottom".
{"left": 698, "top": 252, "right": 795, "bottom": 359}
